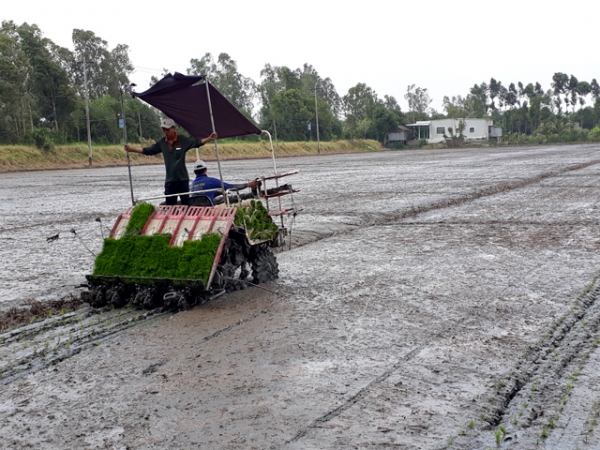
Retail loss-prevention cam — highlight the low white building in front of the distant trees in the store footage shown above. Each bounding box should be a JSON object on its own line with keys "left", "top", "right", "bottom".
{"left": 406, "top": 118, "right": 502, "bottom": 144}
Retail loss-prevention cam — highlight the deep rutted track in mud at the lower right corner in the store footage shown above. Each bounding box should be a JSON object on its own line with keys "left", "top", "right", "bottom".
{"left": 443, "top": 276, "right": 600, "bottom": 449}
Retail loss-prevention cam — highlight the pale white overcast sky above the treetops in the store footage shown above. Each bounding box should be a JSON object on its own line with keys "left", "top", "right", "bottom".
{"left": 5, "top": 0, "right": 600, "bottom": 112}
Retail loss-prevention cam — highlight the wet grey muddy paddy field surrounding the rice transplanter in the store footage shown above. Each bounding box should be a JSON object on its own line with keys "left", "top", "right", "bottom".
{"left": 0, "top": 145, "right": 600, "bottom": 449}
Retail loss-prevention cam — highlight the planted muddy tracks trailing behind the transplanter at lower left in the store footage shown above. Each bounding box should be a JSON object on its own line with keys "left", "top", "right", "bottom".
{"left": 0, "top": 308, "right": 172, "bottom": 385}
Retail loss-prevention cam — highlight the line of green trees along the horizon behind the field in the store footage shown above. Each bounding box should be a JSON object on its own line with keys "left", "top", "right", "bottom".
{"left": 0, "top": 21, "right": 600, "bottom": 148}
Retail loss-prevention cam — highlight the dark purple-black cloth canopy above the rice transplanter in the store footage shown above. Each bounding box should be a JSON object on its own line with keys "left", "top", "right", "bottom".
{"left": 127, "top": 72, "right": 261, "bottom": 139}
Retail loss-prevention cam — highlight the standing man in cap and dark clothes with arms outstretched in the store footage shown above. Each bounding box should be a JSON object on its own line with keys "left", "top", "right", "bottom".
{"left": 125, "top": 118, "right": 218, "bottom": 205}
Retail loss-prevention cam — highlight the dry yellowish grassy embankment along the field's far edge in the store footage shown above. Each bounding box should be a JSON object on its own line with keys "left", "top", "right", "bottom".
{"left": 0, "top": 139, "right": 381, "bottom": 173}
